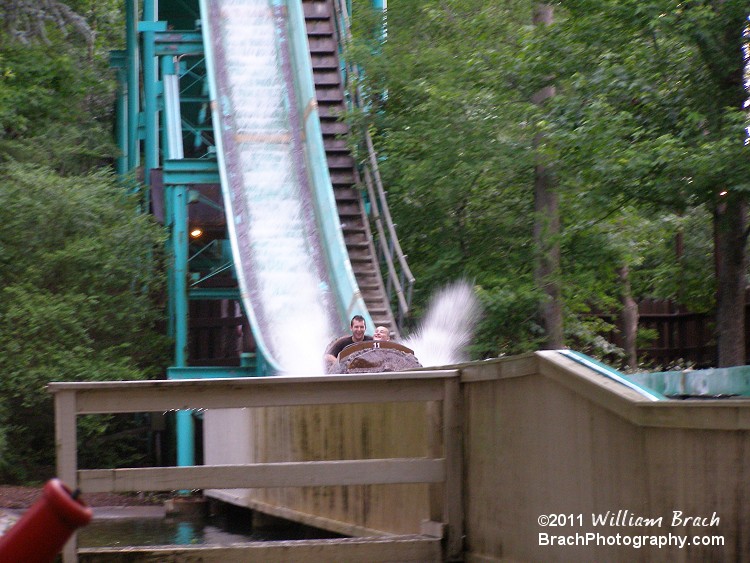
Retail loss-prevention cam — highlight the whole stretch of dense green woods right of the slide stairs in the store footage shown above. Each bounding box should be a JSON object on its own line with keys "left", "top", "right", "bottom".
{"left": 349, "top": 0, "right": 750, "bottom": 367}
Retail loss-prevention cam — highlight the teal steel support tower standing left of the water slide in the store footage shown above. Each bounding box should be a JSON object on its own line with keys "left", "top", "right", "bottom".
{"left": 120, "top": 0, "right": 296, "bottom": 474}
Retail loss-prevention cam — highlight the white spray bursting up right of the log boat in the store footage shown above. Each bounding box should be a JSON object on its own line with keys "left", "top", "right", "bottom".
{"left": 404, "top": 280, "right": 479, "bottom": 367}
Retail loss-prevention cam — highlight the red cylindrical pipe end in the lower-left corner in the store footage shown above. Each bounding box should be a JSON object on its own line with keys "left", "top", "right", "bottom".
{"left": 0, "top": 479, "right": 93, "bottom": 563}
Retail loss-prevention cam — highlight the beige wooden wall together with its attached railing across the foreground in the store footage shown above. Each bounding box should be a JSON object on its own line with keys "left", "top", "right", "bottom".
{"left": 45, "top": 351, "right": 750, "bottom": 563}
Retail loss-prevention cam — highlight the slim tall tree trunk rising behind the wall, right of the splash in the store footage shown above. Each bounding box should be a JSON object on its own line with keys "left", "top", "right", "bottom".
{"left": 532, "top": 4, "right": 564, "bottom": 350}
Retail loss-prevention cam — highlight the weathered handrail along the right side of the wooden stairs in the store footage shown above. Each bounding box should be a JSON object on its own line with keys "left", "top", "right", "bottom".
{"left": 333, "top": 0, "right": 416, "bottom": 326}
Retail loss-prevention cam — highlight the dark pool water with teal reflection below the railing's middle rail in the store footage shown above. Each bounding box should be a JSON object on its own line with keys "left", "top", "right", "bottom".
{"left": 78, "top": 515, "right": 302, "bottom": 547}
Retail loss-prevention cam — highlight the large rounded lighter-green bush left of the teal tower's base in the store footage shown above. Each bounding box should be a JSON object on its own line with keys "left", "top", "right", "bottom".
{"left": 0, "top": 163, "right": 168, "bottom": 479}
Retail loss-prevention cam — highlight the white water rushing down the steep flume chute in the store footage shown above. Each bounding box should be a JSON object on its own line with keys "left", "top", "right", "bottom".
{"left": 211, "top": 0, "right": 335, "bottom": 375}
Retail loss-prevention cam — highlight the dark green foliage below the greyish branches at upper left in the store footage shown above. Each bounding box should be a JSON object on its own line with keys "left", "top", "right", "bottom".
{"left": 0, "top": 6, "right": 121, "bottom": 174}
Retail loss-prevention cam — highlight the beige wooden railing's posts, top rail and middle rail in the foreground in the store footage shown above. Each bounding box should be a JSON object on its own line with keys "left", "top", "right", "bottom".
{"left": 49, "top": 370, "right": 463, "bottom": 563}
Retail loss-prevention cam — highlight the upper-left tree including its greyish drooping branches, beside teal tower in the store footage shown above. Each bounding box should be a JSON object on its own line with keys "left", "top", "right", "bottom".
{"left": 0, "top": 0, "right": 122, "bottom": 174}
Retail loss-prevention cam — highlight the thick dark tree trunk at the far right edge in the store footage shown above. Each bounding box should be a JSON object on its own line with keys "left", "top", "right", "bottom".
{"left": 714, "top": 194, "right": 746, "bottom": 367}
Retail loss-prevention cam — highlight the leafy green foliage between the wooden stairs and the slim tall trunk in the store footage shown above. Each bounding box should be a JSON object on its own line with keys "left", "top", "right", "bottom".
{"left": 354, "top": 1, "right": 552, "bottom": 355}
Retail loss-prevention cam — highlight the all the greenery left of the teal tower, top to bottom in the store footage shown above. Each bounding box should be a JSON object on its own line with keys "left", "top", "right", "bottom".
{"left": 0, "top": 0, "right": 169, "bottom": 481}
